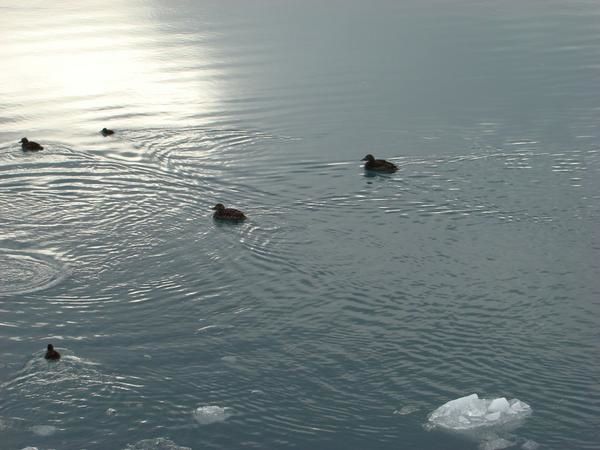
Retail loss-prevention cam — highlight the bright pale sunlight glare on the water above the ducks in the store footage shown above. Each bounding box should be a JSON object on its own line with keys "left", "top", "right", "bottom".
{"left": 0, "top": 2, "right": 221, "bottom": 125}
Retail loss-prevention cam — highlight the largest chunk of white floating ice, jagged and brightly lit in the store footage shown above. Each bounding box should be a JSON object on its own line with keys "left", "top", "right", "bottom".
{"left": 429, "top": 394, "right": 531, "bottom": 431}
